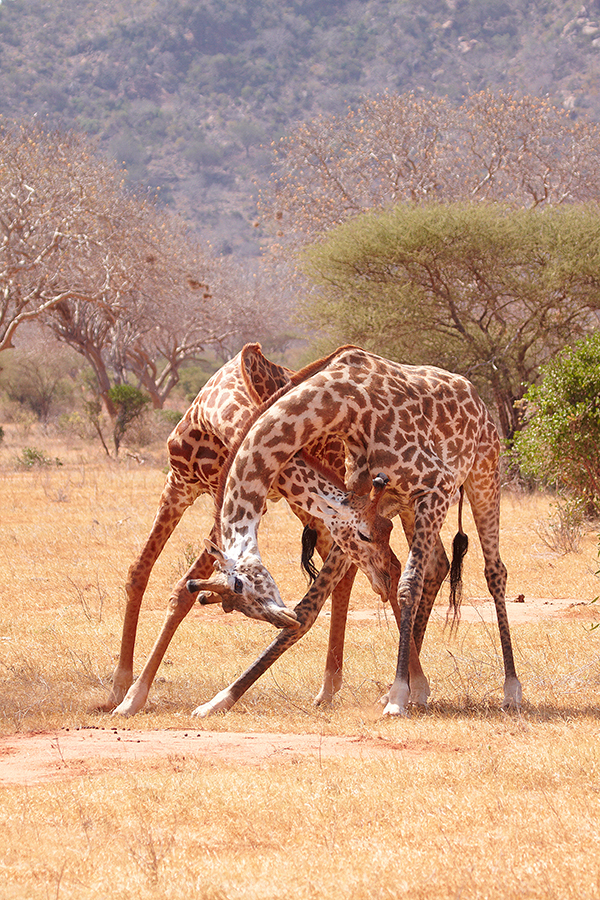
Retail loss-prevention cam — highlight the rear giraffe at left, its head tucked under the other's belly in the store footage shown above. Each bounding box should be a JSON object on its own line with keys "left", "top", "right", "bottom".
{"left": 108, "top": 344, "right": 434, "bottom": 715}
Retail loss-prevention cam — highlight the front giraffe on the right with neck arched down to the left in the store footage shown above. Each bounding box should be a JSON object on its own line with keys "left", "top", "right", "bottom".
{"left": 190, "top": 347, "right": 522, "bottom": 716}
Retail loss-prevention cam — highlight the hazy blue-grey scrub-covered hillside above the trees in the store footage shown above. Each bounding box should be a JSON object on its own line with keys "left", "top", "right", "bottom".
{"left": 0, "top": 0, "right": 600, "bottom": 255}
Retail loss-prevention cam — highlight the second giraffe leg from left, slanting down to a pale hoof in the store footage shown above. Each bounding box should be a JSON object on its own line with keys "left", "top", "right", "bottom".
{"left": 112, "top": 550, "right": 213, "bottom": 716}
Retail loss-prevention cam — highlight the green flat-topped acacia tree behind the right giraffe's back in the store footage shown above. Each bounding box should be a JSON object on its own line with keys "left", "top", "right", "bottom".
{"left": 304, "top": 204, "right": 600, "bottom": 437}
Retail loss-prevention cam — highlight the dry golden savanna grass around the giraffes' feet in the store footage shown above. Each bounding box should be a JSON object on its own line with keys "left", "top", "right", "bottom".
{"left": 0, "top": 424, "right": 600, "bottom": 900}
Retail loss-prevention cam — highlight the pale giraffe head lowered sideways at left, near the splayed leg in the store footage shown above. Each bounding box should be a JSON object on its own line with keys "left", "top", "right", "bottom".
{"left": 187, "top": 540, "right": 298, "bottom": 628}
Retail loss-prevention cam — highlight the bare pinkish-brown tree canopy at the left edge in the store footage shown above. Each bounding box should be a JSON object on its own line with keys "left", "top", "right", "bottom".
{"left": 0, "top": 123, "right": 282, "bottom": 416}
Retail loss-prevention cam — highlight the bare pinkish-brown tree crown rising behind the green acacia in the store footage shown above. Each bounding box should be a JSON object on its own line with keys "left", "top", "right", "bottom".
{"left": 261, "top": 90, "right": 600, "bottom": 243}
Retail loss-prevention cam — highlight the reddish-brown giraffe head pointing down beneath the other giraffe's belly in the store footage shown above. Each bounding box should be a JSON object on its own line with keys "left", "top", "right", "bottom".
{"left": 313, "top": 472, "right": 392, "bottom": 600}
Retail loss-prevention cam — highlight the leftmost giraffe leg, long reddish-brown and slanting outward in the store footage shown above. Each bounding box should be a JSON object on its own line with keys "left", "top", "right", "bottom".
{"left": 102, "top": 471, "right": 200, "bottom": 710}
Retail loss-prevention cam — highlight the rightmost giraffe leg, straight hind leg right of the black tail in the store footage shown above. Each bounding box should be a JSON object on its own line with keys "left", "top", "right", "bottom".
{"left": 465, "top": 466, "right": 523, "bottom": 710}
